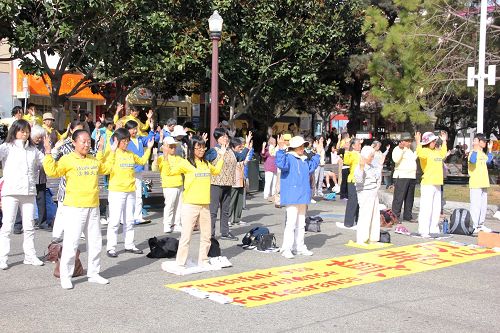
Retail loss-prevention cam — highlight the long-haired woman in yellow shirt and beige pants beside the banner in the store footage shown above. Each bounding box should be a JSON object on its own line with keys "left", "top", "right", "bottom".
{"left": 162, "top": 135, "right": 227, "bottom": 270}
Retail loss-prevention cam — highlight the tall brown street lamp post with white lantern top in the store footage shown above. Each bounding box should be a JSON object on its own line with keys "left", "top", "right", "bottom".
{"left": 208, "top": 10, "right": 223, "bottom": 147}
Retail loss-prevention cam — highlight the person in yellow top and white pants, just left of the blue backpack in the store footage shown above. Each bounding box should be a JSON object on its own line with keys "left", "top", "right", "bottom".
{"left": 415, "top": 131, "right": 448, "bottom": 238}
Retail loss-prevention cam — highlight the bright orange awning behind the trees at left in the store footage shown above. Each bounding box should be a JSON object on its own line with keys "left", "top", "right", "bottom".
{"left": 16, "top": 69, "right": 104, "bottom": 101}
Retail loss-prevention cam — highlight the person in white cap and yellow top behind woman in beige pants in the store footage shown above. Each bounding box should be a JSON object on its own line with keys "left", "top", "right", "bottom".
{"left": 157, "top": 136, "right": 183, "bottom": 233}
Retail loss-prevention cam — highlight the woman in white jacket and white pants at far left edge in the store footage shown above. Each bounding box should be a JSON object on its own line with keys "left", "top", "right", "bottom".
{"left": 0, "top": 119, "right": 44, "bottom": 269}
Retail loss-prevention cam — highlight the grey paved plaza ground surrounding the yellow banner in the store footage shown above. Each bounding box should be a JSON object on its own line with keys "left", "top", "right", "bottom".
{"left": 0, "top": 189, "right": 500, "bottom": 333}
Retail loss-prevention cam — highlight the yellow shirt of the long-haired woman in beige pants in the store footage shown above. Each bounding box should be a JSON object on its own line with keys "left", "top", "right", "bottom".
{"left": 163, "top": 158, "right": 224, "bottom": 205}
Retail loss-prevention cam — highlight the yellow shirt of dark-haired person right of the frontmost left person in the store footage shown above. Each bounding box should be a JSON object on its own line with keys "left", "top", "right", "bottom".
{"left": 105, "top": 148, "right": 151, "bottom": 192}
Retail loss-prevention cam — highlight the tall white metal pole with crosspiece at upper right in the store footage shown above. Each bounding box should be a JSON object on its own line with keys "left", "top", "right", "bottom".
{"left": 477, "top": 0, "right": 488, "bottom": 133}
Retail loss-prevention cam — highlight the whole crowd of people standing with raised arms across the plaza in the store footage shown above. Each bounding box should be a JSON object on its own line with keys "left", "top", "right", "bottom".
{"left": 0, "top": 105, "right": 492, "bottom": 289}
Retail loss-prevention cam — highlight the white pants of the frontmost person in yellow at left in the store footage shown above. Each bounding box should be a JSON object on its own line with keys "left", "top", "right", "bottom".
{"left": 60, "top": 206, "right": 102, "bottom": 279}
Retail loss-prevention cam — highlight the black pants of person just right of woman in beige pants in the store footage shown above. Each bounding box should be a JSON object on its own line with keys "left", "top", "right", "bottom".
{"left": 210, "top": 185, "right": 232, "bottom": 237}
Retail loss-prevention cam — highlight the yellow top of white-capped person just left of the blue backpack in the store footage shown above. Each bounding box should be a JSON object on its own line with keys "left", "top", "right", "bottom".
{"left": 417, "top": 143, "right": 448, "bottom": 185}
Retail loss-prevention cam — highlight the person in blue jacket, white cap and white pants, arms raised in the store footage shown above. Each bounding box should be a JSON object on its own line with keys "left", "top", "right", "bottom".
{"left": 276, "top": 135, "right": 323, "bottom": 259}
